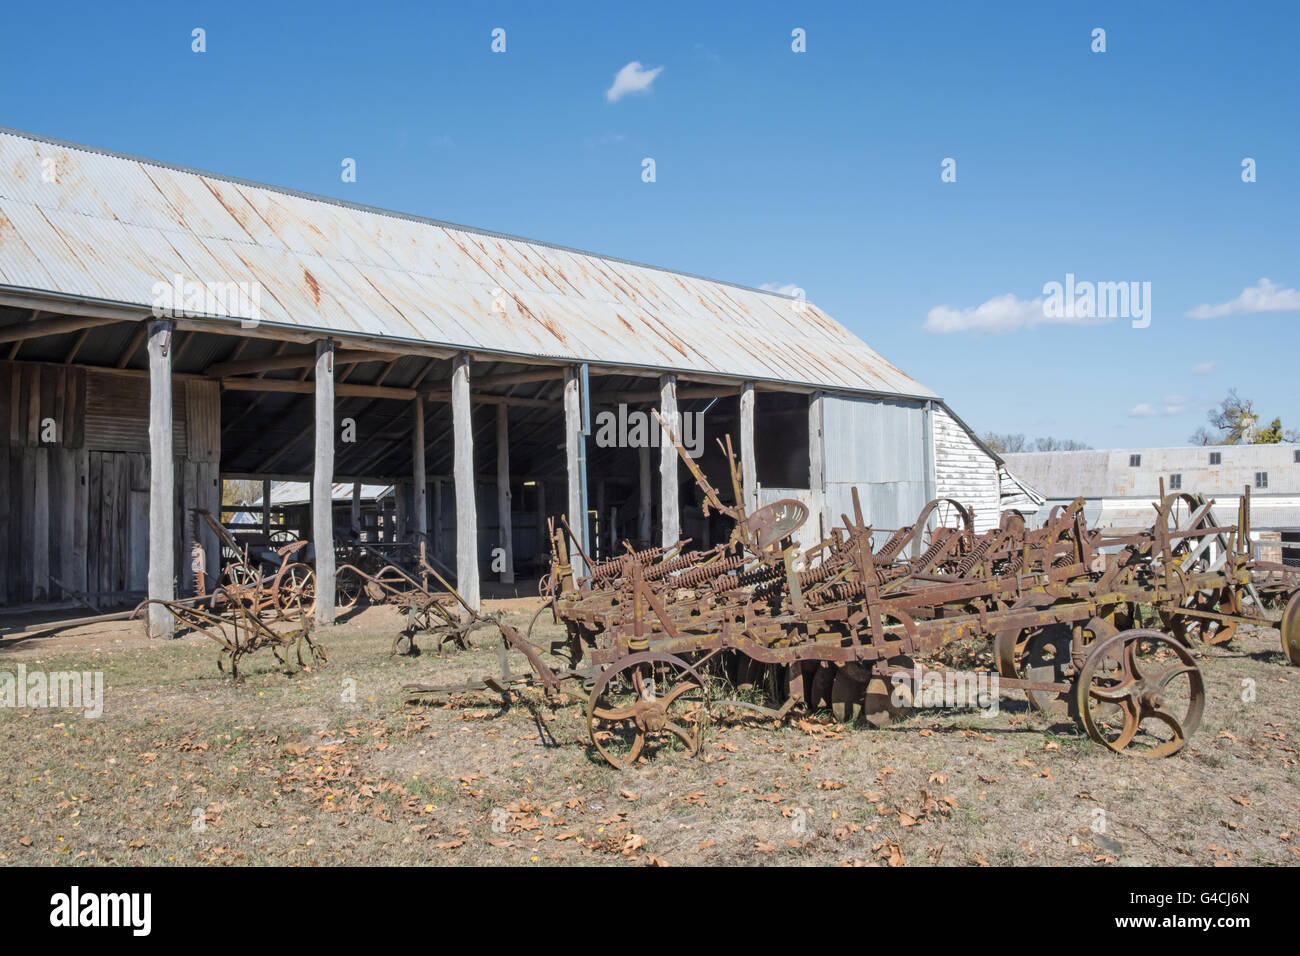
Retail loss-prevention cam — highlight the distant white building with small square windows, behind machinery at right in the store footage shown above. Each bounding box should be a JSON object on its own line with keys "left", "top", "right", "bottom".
{"left": 1004, "top": 444, "right": 1300, "bottom": 548}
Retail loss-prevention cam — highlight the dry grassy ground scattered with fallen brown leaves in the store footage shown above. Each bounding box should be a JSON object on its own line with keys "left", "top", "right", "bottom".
{"left": 0, "top": 601, "right": 1300, "bottom": 866}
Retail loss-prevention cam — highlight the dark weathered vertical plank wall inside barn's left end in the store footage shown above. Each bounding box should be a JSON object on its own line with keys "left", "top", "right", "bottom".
{"left": 0, "top": 362, "right": 221, "bottom": 606}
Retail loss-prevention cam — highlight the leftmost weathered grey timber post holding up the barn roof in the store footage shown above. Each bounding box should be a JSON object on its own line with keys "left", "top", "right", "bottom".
{"left": 148, "top": 320, "right": 176, "bottom": 637}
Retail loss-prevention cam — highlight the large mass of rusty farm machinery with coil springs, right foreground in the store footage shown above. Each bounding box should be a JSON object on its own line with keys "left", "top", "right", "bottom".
{"left": 407, "top": 429, "right": 1300, "bottom": 767}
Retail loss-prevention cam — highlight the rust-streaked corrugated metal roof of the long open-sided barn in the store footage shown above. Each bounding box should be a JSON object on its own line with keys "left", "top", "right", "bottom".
{"left": 0, "top": 127, "right": 935, "bottom": 397}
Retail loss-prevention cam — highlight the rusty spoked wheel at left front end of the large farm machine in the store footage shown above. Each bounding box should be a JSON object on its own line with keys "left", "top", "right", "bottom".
{"left": 586, "top": 650, "right": 709, "bottom": 770}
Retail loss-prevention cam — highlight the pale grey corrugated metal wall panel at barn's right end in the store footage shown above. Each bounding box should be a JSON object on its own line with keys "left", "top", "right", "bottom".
{"left": 822, "top": 395, "right": 930, "bottom": 528}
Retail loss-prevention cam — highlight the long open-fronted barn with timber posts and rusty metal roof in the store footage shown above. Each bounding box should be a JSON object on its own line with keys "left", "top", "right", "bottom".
{"left": 0, "top": 130, "right": 1036, "bottom": 633}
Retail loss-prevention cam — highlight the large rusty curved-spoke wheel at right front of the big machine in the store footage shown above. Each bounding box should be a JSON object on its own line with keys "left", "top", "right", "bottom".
{"left": 1074, "top": 630, "right": 1205, "bottom": 758}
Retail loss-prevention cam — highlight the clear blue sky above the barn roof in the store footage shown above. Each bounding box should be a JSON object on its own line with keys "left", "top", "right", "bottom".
{"left": 0, "top": 0, "right": 1300, "bottom": 447}
